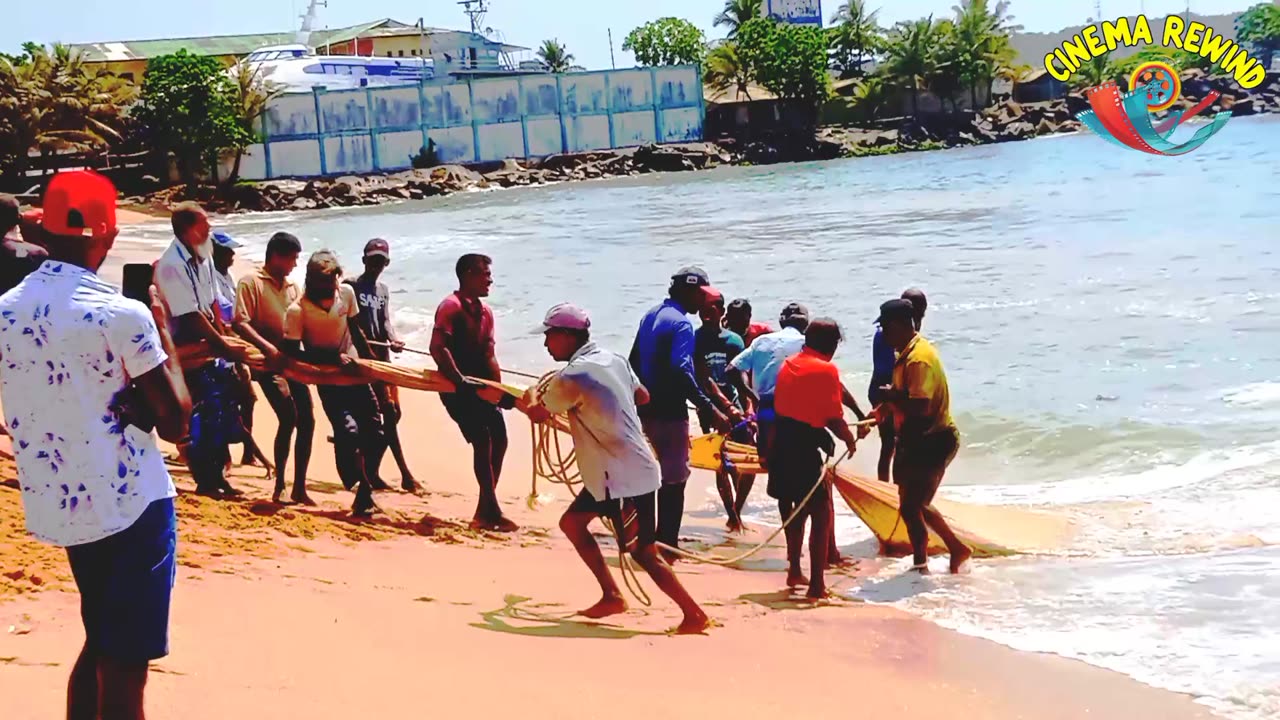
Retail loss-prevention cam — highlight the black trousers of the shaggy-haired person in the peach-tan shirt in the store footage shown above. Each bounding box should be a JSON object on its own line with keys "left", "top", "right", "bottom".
{"left": 317, "top": 384, "right": 387, "bottom": 506}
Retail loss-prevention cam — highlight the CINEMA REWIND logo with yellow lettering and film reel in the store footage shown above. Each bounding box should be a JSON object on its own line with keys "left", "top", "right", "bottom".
{"left": 1044, "top": 15, "right": 1266, "bottom": 155}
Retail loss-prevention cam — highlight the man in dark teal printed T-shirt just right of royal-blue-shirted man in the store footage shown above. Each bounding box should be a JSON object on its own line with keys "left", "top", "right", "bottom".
{"left": 694, "top": 287, "right": 755, "bottom": 533}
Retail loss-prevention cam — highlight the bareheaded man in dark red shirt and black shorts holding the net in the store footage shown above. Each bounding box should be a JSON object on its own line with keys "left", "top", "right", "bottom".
{"left": 431, "top": 254, "right": 520, "bottom": 533}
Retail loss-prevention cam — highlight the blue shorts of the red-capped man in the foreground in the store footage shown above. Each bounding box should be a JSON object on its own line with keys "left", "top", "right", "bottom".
{"left": 67, "top": 497, "right": 178, "bottom": 662}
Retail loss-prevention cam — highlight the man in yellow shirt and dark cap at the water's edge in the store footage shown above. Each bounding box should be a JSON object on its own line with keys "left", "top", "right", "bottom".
{"left": 877, "top": 293, "right": 973, "bottom": 574}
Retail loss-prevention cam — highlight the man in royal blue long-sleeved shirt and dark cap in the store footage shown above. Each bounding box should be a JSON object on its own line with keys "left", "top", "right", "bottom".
{"left": 630, "top": 266, "right": 730, "bottom": 561}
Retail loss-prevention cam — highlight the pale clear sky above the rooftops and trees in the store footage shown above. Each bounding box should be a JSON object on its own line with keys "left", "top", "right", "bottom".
{"left": 0, "top": 0, "right": 1257, "bottom": 69}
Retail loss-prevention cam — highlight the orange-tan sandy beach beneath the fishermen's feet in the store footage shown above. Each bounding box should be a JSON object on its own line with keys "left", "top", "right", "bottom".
{"left": 0, "top": 228, "right": 1210, "bottom": 720}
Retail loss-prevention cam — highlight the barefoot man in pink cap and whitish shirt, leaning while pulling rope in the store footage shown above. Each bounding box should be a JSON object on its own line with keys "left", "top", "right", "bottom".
{"left": 529, "top": 304, "right": 709, "bottom": 634}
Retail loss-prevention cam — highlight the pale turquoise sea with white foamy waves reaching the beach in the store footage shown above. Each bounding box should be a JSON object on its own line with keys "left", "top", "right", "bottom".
{"left": 127, "top": 118, "right": 1280, "bottom": 719}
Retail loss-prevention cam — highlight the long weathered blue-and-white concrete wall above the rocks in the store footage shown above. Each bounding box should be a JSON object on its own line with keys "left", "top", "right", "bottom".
{"left": 241, "top": 65, "right": 703, "bottom": 179}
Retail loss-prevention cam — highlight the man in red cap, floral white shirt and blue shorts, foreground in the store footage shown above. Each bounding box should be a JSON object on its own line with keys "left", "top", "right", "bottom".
{"left": 0, "top": 170, "right": 191, "bottom": 717}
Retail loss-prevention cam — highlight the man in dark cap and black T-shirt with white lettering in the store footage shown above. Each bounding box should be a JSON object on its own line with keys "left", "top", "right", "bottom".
{"left": 347, "top": 238, "right": 419, "bottom": 492}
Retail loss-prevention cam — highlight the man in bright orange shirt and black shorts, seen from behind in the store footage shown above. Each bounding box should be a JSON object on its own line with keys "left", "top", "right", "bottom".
{"left": 768, "top": 318, "right": 858, "bottom": 600}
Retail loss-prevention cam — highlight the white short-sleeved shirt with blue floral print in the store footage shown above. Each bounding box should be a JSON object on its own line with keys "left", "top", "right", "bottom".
{"left": 0, "top": 260, "right": 177, "bottom": 547}
